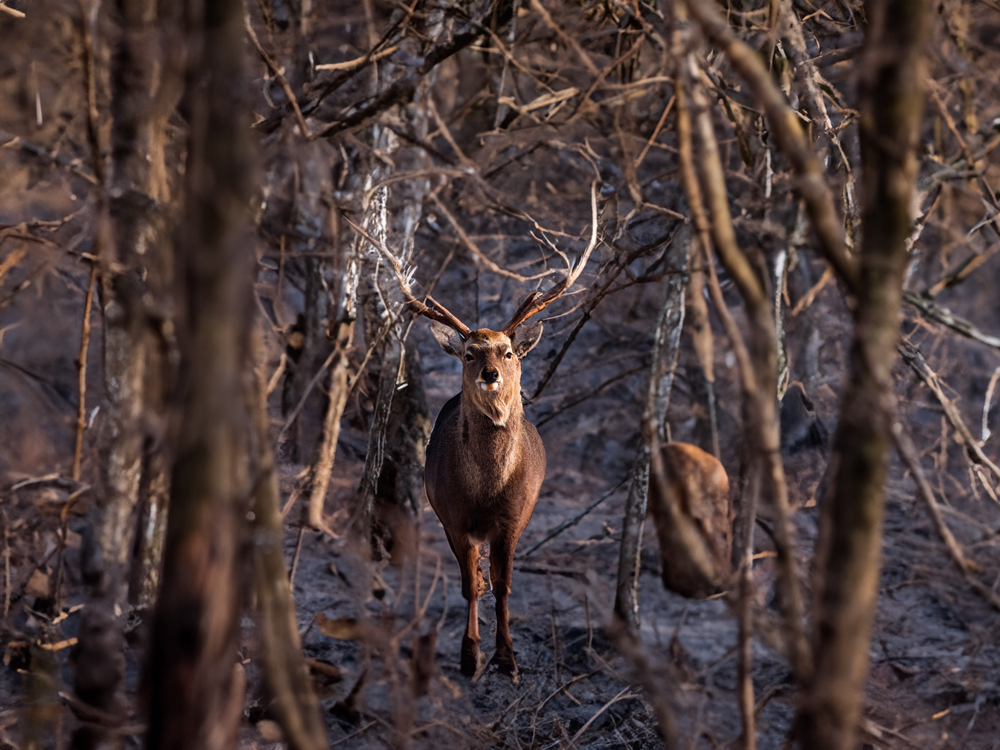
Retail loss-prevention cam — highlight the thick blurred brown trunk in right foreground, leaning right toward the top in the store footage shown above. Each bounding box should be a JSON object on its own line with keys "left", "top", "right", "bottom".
{"left": 798, "top": 0, "right": 930, "bottom": 750}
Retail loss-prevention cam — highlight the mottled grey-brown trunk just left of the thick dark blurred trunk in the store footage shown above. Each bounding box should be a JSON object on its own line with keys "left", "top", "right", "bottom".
{"left": 73, "top": 0, "right": 170, "bottom": 748}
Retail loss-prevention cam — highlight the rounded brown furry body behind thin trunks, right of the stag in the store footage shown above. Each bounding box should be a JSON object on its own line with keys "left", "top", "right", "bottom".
{"left": 649, "top": 443, "right": 733, "bottom": 599}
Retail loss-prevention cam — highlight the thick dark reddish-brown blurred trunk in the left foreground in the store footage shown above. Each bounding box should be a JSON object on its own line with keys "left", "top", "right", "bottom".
{"left": 145, "top": 0, "right": 255, "bottom": 750}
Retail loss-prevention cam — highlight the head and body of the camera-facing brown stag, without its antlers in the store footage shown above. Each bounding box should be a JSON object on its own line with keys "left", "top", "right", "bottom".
{"left": 424, "top": 323, "right": 545, "bottom": 682}
